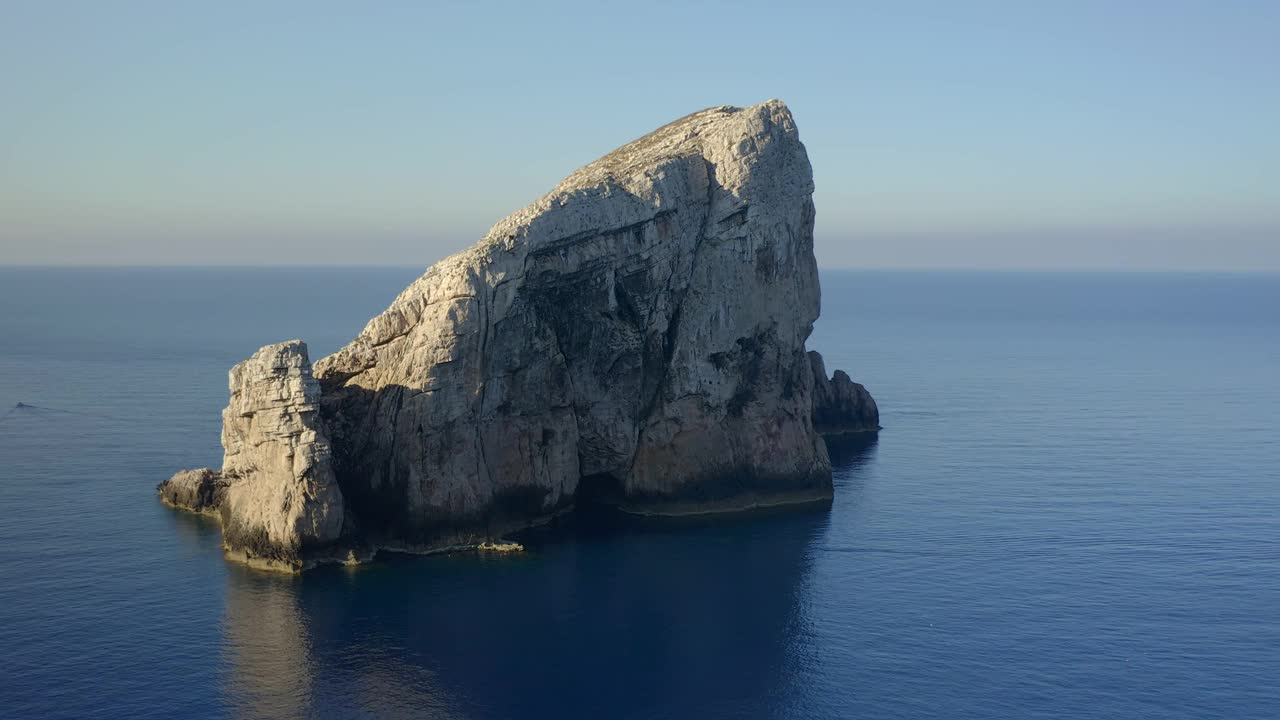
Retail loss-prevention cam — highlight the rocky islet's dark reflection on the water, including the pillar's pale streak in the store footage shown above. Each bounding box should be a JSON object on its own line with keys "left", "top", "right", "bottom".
{"left": 217, "top": 484, "right": 860, "bottom": 717}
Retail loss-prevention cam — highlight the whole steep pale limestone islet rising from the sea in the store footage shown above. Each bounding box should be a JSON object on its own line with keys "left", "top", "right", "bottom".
{"left": 159, "top": 100, "right": 879, "bottom": 571}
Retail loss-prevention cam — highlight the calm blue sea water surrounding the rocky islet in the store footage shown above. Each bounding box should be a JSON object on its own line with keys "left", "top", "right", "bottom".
{"left": 0, "top": 269, "right": 1280, "bottom": 720}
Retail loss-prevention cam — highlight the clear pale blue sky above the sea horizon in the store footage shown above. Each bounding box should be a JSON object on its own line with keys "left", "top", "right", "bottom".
{"left": 0, "top": 0, "right": 1280, "bottom": 270}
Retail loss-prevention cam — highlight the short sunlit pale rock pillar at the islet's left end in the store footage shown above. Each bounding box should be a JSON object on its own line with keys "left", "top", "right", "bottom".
{"left": 221, "top": 341, "right": 343, "bottom": 568}
